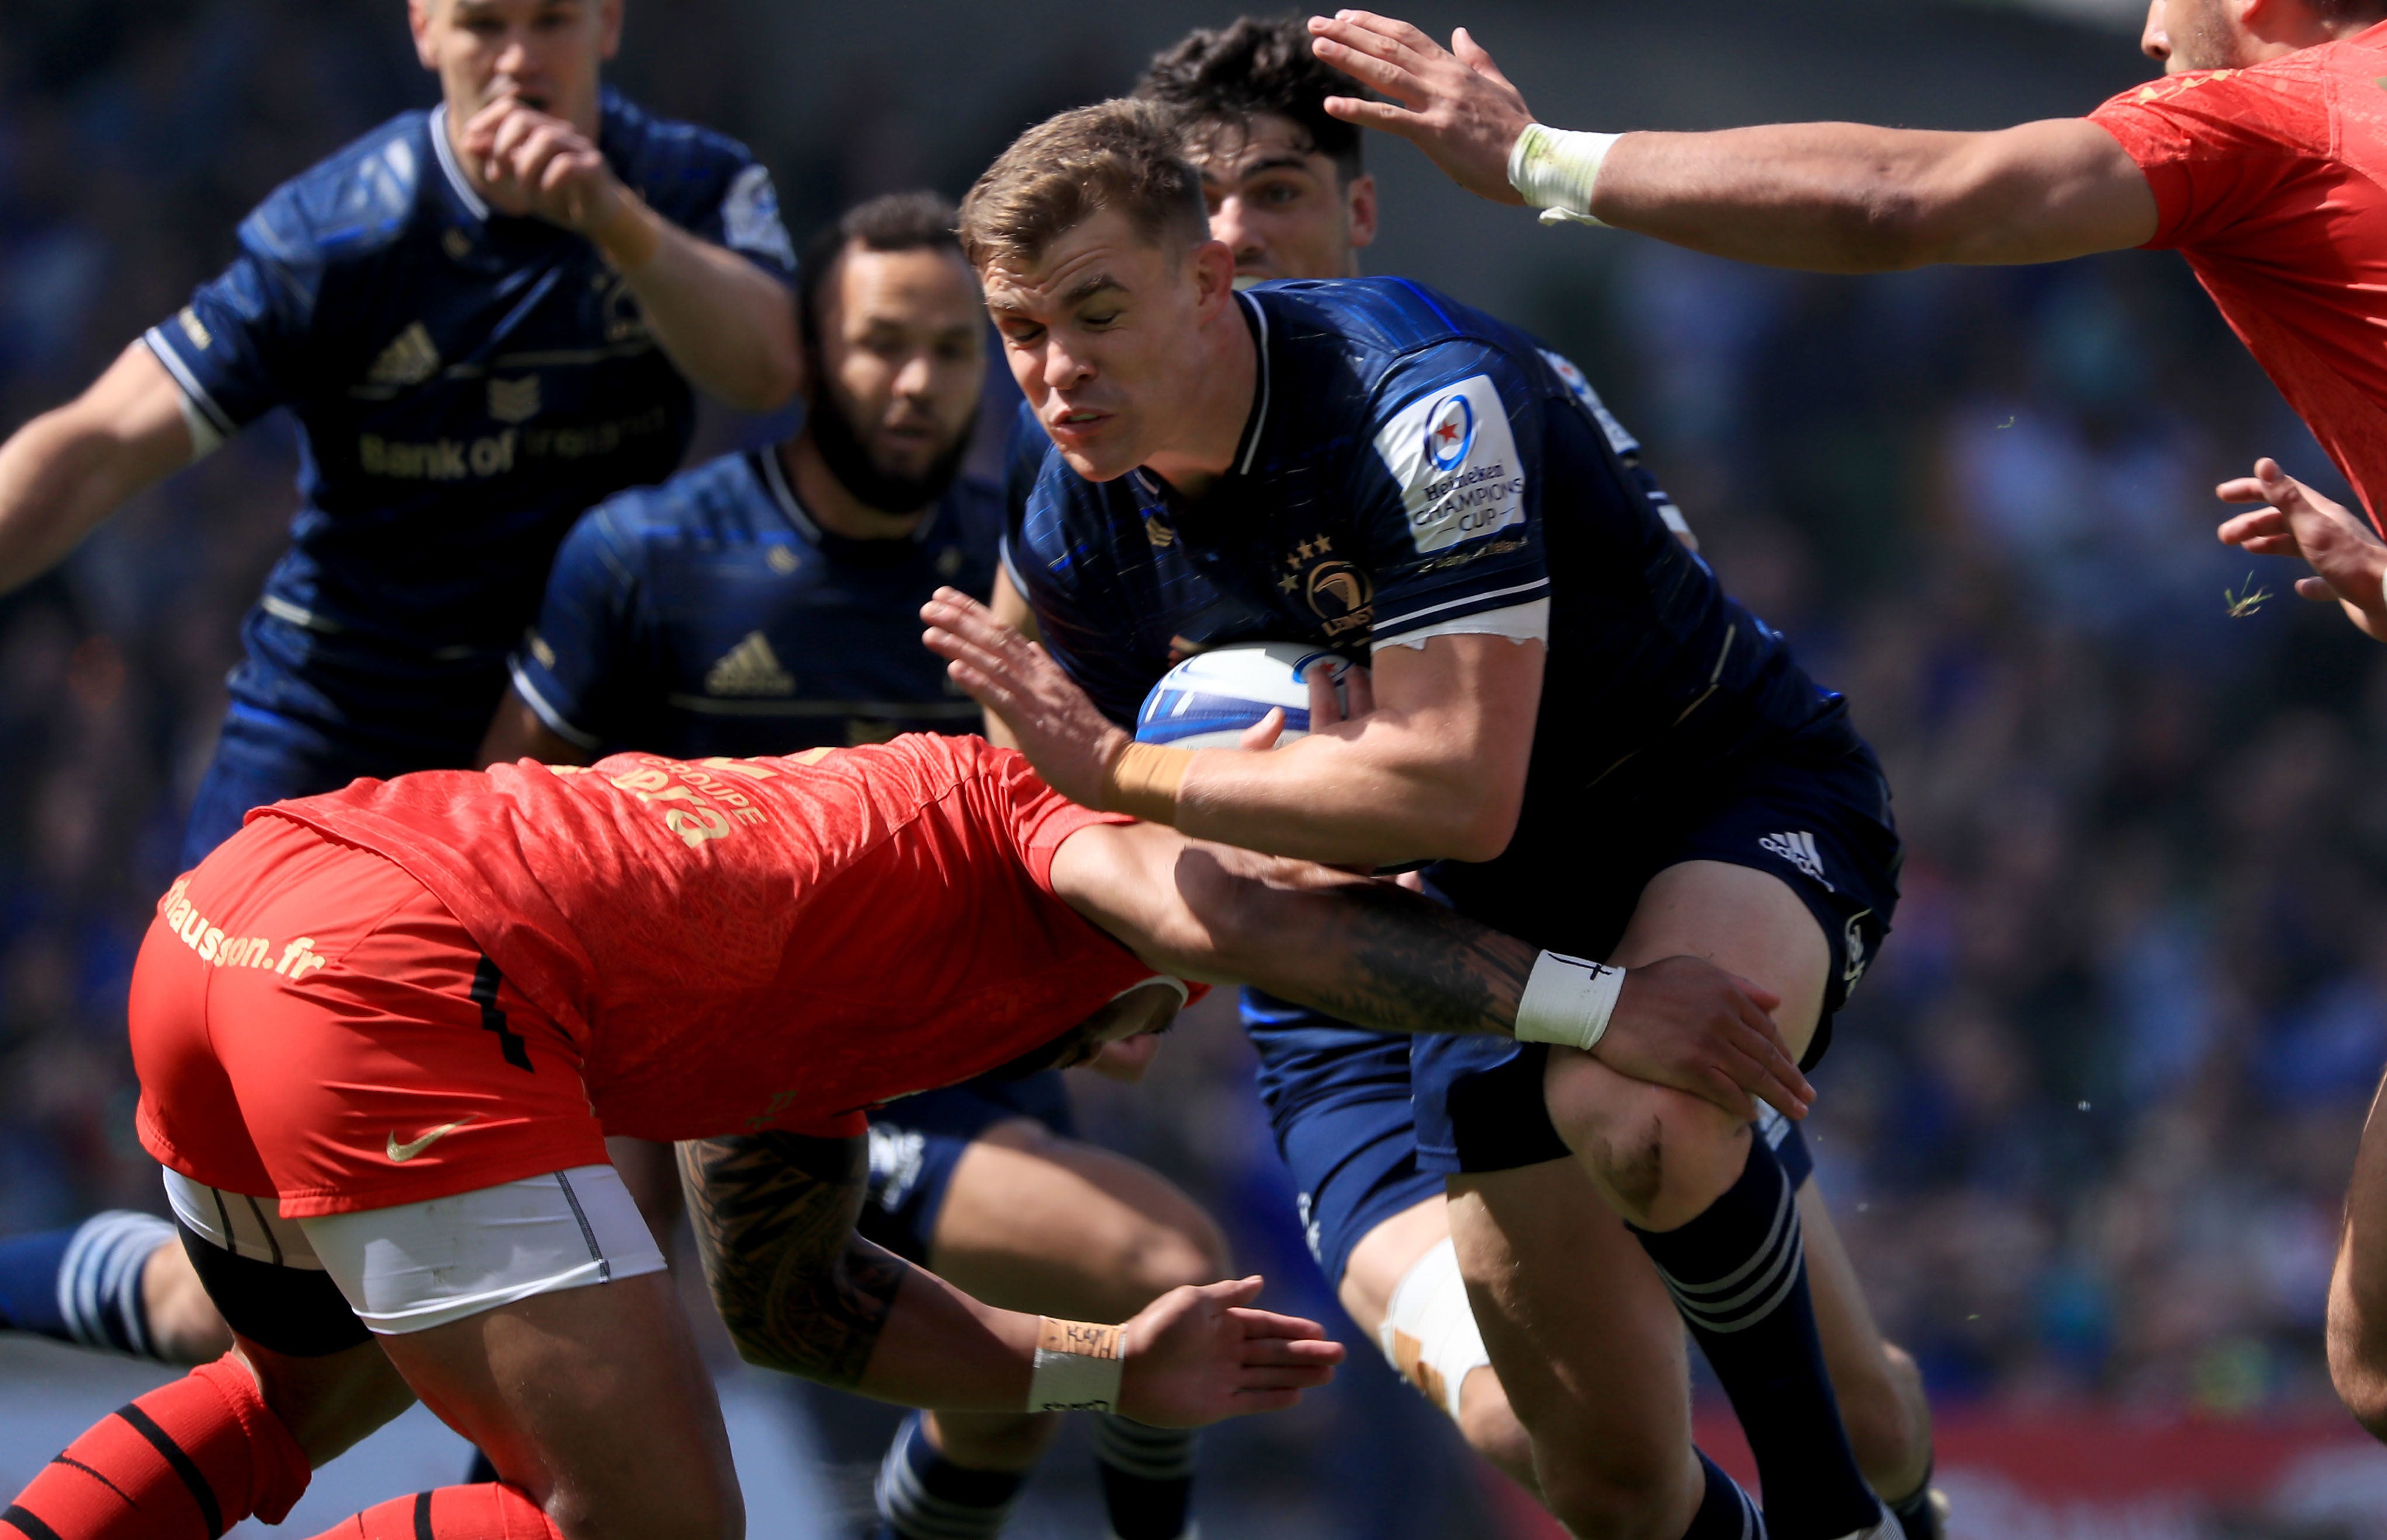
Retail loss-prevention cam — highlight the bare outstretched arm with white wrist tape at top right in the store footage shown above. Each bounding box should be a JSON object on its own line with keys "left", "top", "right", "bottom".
{"left": 1310, "top": 12, "right": 2156, "bottom": 272}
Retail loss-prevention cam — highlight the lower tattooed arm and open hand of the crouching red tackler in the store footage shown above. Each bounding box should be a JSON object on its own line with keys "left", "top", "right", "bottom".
{"left": 680, "top": 1134, "right": 1341, "bottom": 1428}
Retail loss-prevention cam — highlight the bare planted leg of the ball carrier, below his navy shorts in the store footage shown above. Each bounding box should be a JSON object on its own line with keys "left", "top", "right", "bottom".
{"left": 1449, "top": 1160, "right": 1700, "bottom": 1533}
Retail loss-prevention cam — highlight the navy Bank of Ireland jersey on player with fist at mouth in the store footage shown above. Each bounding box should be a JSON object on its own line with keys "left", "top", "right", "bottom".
{"left": 146, "top": 91, "right": 795, "bottom": 764}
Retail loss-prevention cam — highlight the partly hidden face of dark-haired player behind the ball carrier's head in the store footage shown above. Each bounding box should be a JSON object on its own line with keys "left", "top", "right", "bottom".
{"left": 1186, "top": 112, "right": 1375, "bottom": 282}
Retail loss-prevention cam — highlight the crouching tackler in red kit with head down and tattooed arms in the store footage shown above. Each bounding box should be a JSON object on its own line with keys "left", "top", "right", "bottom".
{"left": 0, "top": 735, "right": 1812, "bottom": 1540}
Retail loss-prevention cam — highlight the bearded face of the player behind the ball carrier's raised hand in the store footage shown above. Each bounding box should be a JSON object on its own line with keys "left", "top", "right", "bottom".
{"left": 821, "top": 246, "right": 986, "bottom": 482}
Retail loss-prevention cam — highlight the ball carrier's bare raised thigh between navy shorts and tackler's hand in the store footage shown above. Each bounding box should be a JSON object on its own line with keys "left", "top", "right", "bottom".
{"left": 1611, "top": 862, "right": 1831, "bottom": 1053}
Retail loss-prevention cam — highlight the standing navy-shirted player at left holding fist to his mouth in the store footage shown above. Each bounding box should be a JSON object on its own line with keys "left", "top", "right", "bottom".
{"left": 0, "top": 0, "right": 800, "bottom": 1404}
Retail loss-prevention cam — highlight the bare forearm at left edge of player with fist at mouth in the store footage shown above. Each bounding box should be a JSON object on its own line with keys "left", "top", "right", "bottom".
{"left": 0, "top": 341, "right": 191, "bottom": 592}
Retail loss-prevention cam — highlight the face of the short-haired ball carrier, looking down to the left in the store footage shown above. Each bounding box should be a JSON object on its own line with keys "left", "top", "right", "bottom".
{"left": 986, "top": 210, "right": 1234, "bottom": 482}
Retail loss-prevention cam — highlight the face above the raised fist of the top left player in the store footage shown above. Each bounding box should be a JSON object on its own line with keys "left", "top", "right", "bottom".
{"left": 406, "top": 0, "right": 621, "bottom": 134}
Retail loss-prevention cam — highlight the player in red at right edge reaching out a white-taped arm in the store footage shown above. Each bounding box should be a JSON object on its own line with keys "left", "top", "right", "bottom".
{"left": 1310, "top": 0, "right": 2387, "bottom": 1437}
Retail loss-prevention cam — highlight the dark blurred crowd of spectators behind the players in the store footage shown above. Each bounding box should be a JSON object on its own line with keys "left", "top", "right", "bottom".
{"left": 0, "top": 0, "right": 2387, "bottom": 1538}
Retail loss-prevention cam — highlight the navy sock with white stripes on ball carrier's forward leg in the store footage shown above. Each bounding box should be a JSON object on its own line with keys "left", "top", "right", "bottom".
{"left": 1635, "top": 1137, "right": 1881, "bottom": 1540}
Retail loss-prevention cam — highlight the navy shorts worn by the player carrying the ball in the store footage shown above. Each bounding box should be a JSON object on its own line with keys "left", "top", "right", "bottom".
{"left": 1411, "top": 724, "right": 1900, "bottom": 1172}
